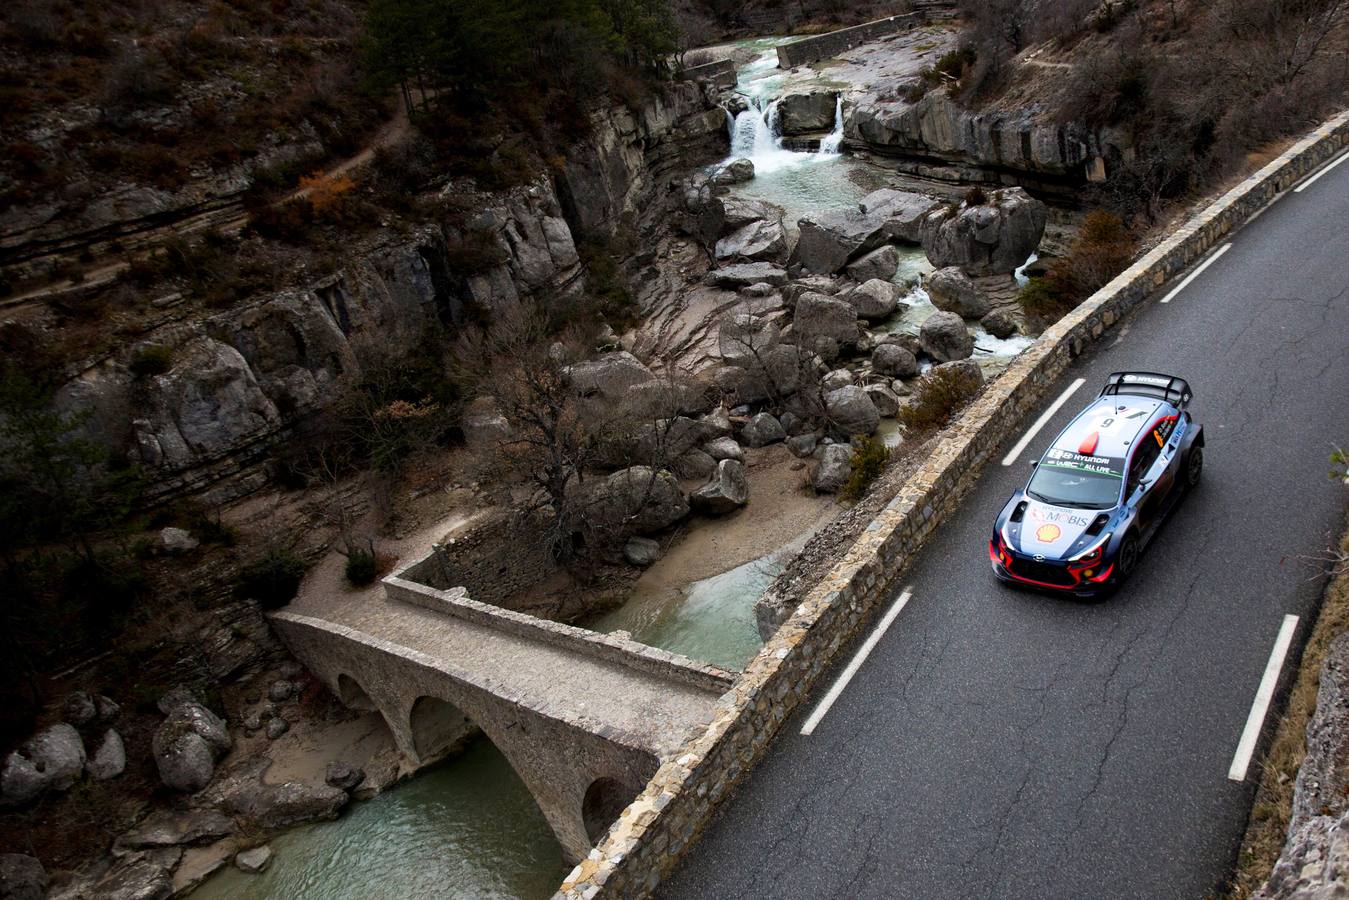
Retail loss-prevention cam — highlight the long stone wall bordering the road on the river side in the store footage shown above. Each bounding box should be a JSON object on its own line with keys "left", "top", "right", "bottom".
{"left": 557, "top": 112, "right": 1349, "bottom": 900}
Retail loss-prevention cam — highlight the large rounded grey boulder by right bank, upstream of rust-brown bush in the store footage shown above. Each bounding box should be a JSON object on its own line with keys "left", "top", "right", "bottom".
{"left": 923, "top": 188, "right": 1047, "bottom": 275}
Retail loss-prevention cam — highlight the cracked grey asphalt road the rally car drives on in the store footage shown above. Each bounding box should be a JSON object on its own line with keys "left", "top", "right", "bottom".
{"left": 660, "top": 151, "right": 1349, "bottom": 900}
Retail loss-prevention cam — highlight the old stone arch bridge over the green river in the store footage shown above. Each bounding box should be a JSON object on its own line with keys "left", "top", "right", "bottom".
{"left": 272, "top": 557, "right": 733, "bottom": 862}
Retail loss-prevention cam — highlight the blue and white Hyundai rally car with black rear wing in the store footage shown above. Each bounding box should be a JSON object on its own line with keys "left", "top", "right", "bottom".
{"left": 989, "top": 372, "right": 1203, "bottom": 596}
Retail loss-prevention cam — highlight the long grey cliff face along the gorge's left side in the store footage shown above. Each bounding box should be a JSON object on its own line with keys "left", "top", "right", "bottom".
{"left": 57, "top": 84, "right": 724, "bottom": 501}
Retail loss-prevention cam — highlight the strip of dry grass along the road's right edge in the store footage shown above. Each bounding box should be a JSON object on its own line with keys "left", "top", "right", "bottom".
{"left": 1221, "top": 518, "right": 1349, "bottom": 900}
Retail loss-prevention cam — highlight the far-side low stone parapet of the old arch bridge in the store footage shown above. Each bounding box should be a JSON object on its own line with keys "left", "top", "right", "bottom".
{"left": 383, "top": 555, "right": 735, "bottom": 694}
